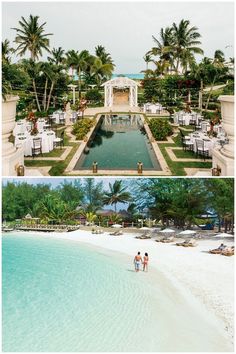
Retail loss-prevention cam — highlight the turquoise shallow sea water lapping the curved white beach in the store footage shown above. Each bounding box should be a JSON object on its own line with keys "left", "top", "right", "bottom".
{"left": 2, "top": 234, "right": 228, "bottom": 352}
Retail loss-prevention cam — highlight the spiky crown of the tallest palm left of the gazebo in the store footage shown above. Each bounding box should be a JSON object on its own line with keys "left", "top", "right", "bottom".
{"left": 13, "top": 15, "right": 52, "bottom": 61}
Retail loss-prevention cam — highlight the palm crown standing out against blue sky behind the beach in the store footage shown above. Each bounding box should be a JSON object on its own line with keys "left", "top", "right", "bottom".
{"left": 103, "top": 180, "right": 132, "bottom": 212}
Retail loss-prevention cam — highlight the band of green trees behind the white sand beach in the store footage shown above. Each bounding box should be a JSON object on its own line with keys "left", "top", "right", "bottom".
{"left": 2, "top": 178, "right": 234, "bottom": 234}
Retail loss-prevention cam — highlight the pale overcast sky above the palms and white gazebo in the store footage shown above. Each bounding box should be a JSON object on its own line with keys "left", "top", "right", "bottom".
{"left": 2, "top": 1, "right": 234, "bottom": 74}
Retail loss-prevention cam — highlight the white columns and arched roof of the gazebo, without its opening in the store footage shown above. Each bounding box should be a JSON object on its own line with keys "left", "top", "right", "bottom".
{"left": 102, "top": 77, "right": 138, "bottom": 107}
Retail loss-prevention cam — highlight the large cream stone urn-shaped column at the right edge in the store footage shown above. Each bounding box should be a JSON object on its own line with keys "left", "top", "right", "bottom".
{"left": 212, "top": 96, "right": 234, "bottom": 176}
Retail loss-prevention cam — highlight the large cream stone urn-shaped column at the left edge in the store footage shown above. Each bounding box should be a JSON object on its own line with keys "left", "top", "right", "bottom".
{"left": 2, "top": 96, "right": 24, "bottom": 176}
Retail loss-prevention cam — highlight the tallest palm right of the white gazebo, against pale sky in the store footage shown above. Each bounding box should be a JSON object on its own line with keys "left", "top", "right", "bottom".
{"left": 172, "top": 20, "right": 203, "bottom": 74}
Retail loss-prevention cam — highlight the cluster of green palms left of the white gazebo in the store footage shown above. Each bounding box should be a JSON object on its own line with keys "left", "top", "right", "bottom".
{"left": 2, "top": 15, "right": 115, "bottom": 111}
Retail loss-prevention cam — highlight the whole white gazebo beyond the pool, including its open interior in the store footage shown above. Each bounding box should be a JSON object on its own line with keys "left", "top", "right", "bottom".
{"left": 102, "top": 77, "right": 139, "bottom": 107}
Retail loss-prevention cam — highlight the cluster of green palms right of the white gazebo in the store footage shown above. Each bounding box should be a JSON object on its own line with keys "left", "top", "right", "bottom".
{"left": 143, "top": 19, "right": 234, "bottom": 110}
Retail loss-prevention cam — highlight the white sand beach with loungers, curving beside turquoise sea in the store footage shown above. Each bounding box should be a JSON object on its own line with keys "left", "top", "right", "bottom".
{"left": 7, "top": 230, "right": 234, "bottom": 345}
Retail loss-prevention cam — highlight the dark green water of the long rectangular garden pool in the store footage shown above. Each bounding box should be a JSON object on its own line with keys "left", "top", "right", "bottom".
{"left": 75, "top": 115, "right": 161, "bottom": 170}
